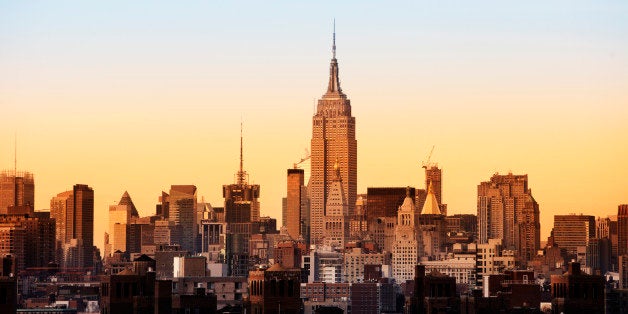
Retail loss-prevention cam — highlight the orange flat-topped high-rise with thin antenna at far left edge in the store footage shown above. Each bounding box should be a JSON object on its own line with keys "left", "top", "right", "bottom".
{"left": 0, "top": 170, "right": 35, "bottom": 214}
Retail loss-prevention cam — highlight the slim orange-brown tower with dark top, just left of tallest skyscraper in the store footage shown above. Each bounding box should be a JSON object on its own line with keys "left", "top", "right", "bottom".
{"left": 283, "top": 168, "right": 305, "bottom": 240}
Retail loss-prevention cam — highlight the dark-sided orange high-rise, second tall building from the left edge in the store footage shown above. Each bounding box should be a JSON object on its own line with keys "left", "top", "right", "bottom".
{"left": 50, "top": 184, "right": 94, "bottom": 268}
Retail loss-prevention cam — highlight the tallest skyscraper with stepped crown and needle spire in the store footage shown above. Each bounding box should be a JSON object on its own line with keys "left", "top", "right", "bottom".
{"left": 309, "top": 27, "right": 358, "bottom": 244}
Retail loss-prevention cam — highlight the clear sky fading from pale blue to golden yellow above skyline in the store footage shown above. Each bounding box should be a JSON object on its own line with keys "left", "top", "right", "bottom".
{"left": 0, "top": 0, "right": 628, "bottom": 251}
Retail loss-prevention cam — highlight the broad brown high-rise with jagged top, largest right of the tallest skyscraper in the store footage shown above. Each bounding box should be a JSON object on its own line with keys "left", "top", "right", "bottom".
{"left": 477, "top": 173, "right": 541, "bottom": 262}
